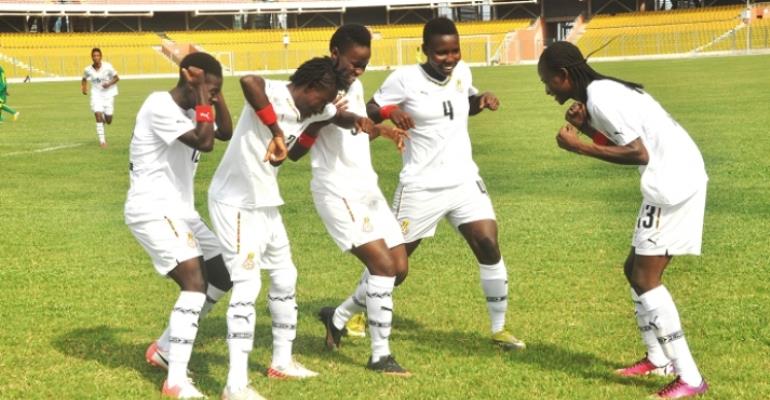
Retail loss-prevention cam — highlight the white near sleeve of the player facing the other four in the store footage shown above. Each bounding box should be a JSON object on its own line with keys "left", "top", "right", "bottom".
{"left": 588, "top": 87, "right": 642, "bottom": 146}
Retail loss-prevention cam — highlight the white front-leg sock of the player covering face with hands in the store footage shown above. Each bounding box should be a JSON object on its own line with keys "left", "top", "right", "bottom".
{"left": 168, "top": 291, "right": 206, "bottom": 387}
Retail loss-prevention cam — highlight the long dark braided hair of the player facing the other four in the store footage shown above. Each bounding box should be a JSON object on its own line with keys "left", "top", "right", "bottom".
{"left": 537, "top": 42, "right": 644, "bottom": 103}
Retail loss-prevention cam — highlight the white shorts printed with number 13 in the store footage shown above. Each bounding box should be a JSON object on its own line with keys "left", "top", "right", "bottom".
{"left": 631, "top": 186, "right": 706, "bottom": 256}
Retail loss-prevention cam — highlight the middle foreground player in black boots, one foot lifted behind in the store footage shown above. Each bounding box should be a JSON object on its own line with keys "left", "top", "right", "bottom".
{"left": 289, "top": 24, "right": 409, "bottom": 376}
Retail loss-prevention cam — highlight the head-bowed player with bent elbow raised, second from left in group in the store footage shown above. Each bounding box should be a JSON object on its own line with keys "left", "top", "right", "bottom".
{"left": 209, "top": 57, "right": 371, "bottom": 399}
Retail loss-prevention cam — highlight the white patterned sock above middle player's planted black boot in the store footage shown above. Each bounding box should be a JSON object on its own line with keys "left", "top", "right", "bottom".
{"left": 366, "top": 275, "right": 396, "bottom": 362}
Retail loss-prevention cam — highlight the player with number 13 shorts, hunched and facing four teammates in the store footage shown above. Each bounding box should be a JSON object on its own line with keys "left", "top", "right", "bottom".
{"left": 538, "top": 42, "right": 708, "bottom": 398}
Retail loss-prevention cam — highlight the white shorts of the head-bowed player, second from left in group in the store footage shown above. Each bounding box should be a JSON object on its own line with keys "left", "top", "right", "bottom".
{"left": 209, "top": 198, "right": 295, "bottom": 282}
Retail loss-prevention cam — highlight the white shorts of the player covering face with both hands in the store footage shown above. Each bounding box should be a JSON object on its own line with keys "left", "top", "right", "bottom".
{"left": 128, "top": 218, "right": 222, "bottom": 275}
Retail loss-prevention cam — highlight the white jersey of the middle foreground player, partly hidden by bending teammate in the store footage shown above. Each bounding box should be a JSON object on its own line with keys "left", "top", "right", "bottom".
{"left": 310, "top": 79, "right": 379, "bottom": 197}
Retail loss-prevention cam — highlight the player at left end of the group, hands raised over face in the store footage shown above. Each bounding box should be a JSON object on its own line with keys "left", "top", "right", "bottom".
{"left": 124, "top": 53, "right": 232, "bottom": 399}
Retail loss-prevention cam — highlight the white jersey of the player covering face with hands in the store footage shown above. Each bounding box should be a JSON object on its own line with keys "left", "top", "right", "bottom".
{"left": 125, "top": 92, "right": 200, "bottom": 224}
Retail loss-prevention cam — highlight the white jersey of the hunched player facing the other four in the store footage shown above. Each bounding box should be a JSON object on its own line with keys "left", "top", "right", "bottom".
{"left": 587, "top": 79, "right": 708, "bottom": 205}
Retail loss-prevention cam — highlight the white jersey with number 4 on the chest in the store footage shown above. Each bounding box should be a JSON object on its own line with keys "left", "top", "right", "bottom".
{"left": 374, "top": 61, "right": 479, "bottom": 189}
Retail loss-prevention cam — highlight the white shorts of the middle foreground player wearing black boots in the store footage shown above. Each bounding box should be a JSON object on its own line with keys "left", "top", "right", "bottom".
{"left": 313, "top": 191, "right": 404, "bottom": 251}
